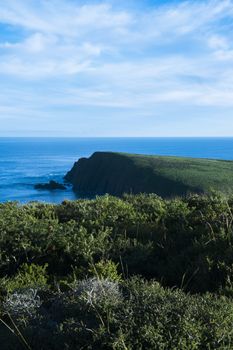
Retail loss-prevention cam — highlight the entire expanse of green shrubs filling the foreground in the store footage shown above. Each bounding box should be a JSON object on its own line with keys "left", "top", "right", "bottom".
{"left": 0, "top": 192, "right": 233, "bottom": 350}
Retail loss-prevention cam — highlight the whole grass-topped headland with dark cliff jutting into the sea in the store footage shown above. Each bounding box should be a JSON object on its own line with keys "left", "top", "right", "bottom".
{"left": 65, "top": 152, "right": 233, "bottom": 197}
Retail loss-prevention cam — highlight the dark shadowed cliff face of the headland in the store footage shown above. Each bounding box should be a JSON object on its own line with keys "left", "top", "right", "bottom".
{"left": 65, "top": 152, "right": 201, "bottom": 197}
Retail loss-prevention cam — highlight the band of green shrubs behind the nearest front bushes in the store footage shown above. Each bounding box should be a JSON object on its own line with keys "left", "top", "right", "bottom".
{"left": 0, "top": 193, "right": 233, "bottom": 292}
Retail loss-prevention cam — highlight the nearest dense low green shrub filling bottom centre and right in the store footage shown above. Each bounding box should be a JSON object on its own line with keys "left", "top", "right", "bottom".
{"left": 0, "top": 278, "right": 233, "bottom": 350}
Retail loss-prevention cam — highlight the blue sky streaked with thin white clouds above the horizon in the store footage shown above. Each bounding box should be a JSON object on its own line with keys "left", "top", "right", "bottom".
{"left": 0, "top": 0, "right": 233, "bottom": 137}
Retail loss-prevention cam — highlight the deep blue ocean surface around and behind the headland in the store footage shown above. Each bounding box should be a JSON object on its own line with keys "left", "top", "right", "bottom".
{"left": 0, "top": 138, "right": 233, "bottom": 203}
